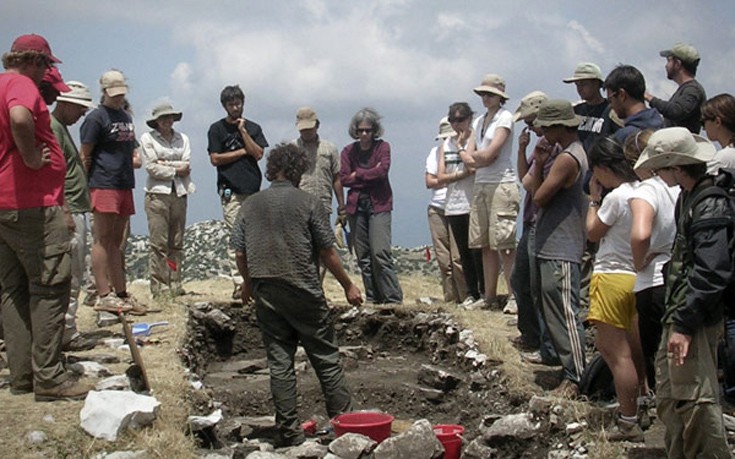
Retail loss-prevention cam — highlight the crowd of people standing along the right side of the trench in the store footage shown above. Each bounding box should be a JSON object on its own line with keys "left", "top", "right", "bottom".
{"left": 426, "top": 44, "right": 735, "bottom": 457}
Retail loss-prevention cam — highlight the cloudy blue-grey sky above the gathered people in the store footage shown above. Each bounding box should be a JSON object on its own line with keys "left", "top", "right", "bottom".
{"left": 0, "top": 0, "right": 735, "bottom": 247}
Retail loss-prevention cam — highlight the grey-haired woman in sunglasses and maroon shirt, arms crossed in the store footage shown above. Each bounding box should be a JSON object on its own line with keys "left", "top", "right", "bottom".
{"left": 339, "top": 108, "right": 403, "bottom": 304}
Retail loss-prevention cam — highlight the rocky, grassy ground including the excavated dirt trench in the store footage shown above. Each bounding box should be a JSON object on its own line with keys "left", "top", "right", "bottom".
{"left": 0, "top": 222, "right": 732, "bottom": 459}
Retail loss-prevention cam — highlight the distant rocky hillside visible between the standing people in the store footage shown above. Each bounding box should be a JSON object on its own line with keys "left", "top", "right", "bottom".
{"left": 124, "top": 220, "right": 439, "bottom": 282}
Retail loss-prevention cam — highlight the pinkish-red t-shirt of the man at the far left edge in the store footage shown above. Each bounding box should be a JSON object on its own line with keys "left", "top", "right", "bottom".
{"left": 0, "top": 72, "right": 66, "bottom": 210}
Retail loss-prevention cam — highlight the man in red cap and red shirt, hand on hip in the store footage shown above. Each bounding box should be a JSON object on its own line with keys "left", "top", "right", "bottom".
{"left": 0, "top": 35, "right": 89, "bottom": 401}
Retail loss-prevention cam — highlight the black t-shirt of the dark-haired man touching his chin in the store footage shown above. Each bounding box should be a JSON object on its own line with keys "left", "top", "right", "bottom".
{"left": 207, "top": 118, "right": 268, "bottom": 194}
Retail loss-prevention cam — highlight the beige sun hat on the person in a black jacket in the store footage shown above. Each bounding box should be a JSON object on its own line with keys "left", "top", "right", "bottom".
{"left": 633, "top": 127, "right": 716, "bottom": 170}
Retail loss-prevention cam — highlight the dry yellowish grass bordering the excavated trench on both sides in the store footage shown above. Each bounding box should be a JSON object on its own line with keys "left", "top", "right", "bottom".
{"left": 0, "top": 276, "right": 614, "bottom": 458}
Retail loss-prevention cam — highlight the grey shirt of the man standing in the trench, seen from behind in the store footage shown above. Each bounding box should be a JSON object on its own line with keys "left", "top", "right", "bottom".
{"left": 230, "top": 181, "right": 336, "bottom": 298}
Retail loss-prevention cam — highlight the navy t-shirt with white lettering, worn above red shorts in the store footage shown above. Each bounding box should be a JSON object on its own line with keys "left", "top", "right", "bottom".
{"left": 79, "top": 105, "right": 136, "bottom": 190}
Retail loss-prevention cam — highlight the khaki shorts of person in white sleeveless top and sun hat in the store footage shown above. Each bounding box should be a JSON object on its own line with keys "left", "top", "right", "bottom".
{"left": 469, "top": 182, "right": 521, "bottom": 250}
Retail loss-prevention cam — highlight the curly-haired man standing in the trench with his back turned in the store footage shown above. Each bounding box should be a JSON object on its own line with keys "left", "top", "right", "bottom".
{"left": 231, "top": 143, "right": 362, "bottom": 446}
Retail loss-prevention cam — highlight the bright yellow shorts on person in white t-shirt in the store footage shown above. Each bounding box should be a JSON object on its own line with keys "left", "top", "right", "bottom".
{"left": 587, "top": 273, "right": 637, "bottom": 330}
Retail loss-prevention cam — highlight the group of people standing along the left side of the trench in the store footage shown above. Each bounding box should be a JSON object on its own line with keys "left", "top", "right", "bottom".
{"left": 0, "top": 34, "right": 193, "bottom": 401}
